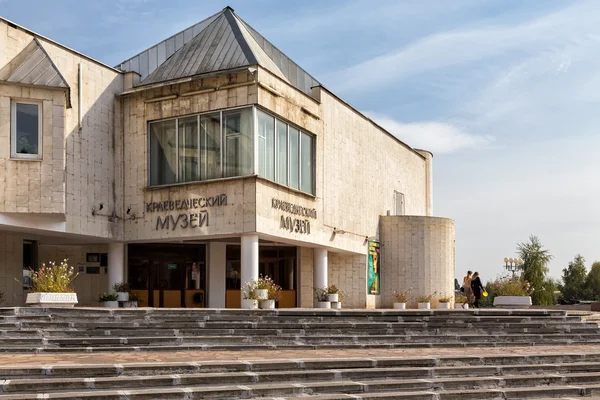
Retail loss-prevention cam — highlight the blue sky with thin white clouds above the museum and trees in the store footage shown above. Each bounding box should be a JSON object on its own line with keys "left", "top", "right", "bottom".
{"left": 0, "top": 0, "right": 600, "bottom": 281}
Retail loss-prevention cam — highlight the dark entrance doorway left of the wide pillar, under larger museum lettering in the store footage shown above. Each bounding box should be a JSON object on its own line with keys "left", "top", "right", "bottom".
{"left": 128, "top": 244, "right": 206, "bottom": 308}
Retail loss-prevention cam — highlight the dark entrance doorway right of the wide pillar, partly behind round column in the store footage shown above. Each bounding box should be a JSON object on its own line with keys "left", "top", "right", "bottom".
{"left": 225, "top": 245, "right": 297, "bottom": 308}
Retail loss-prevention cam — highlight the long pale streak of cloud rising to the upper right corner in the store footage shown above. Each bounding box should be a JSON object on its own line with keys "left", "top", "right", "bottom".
{"left": 330, "top": 2, "right": 600, "bottom": 93}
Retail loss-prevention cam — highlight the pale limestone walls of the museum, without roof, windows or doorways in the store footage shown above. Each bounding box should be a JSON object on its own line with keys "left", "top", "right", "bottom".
{"left": 0, "top": 10, "right": 454, "bottom": 308}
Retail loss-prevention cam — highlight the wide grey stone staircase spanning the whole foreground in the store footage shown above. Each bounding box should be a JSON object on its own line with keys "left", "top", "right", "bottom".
{"left": 0, "top": 308, "right": 600, "bottom": 400}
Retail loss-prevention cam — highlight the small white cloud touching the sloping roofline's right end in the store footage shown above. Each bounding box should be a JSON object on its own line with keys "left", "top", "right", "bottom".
{"left": 365, "top": 112, "right": 494, "bottom": 154}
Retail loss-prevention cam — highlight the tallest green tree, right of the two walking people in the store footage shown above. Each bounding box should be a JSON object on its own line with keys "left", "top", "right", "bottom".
{"left": 517, "top": 235, "right": 553, "bottom": 305}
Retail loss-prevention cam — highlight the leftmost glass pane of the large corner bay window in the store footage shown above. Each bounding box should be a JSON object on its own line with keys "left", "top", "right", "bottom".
{"left": 150, "top": 120, "right": 177, "bottom": 185}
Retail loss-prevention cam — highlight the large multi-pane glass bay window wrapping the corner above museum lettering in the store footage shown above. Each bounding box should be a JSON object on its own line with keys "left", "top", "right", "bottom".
{"left": 148, "top": 107, "right": 315, "bottom": 194}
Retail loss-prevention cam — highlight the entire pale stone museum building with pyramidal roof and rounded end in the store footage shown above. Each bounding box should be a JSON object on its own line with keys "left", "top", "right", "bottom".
{"left": 0, "top": 7, "right": 454, "bottom": 308}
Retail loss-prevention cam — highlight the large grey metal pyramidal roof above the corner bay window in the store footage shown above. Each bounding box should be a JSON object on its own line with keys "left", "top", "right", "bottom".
{"left": 117, "top": 7, "right": 319, "bottom": 95}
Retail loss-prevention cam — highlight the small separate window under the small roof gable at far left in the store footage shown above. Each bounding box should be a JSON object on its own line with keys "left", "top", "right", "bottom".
{"left": 10, "top": 101, "right": 42, "bottom": 160}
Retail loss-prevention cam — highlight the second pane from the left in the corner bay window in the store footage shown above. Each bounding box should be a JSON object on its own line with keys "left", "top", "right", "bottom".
{"left": 179, "top": 117, "right": 199, "bottom": 182}
